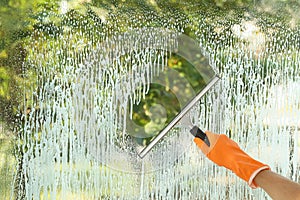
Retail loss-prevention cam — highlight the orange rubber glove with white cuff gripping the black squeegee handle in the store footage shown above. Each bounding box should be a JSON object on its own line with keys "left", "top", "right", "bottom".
{"left": 194, "top": 131, "right": 270, "bottom": 188}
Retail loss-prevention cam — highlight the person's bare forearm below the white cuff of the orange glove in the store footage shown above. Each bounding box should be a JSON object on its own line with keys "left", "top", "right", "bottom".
{"left": 254, "top": 170, "right": 300, "bottom": 200}
